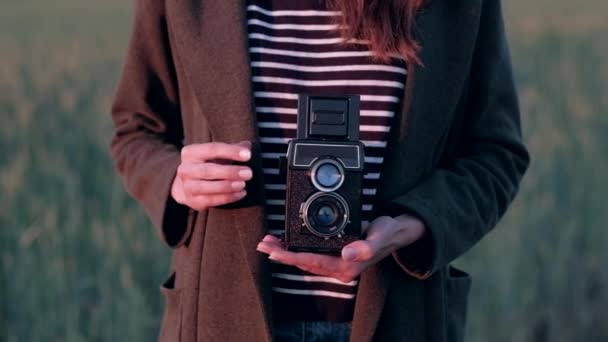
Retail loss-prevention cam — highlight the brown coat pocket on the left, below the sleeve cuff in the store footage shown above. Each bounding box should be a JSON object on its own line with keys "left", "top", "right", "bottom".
{"left": 158, "top": 272, "right": 182, "bottom": 342}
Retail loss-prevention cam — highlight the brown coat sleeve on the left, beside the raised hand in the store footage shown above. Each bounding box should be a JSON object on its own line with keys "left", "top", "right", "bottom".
{"left": 110, "top": 0, "right": 192, "bottom": 247}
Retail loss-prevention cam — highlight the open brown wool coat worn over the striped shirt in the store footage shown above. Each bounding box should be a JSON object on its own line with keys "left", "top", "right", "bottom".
{"left": 111, "top": 0, "right": 528, "bottom": 342}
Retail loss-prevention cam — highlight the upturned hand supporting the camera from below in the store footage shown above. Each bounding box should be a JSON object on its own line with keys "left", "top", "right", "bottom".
{"left": 257, "top": 215, "right": 426, "bottom": 283}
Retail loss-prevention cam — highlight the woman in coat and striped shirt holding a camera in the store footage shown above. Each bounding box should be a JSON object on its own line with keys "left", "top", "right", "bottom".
{"left": 111, "top": 0, "right": 529, "bottom": 342}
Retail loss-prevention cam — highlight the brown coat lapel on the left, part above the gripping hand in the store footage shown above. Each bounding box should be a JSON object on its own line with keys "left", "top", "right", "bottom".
{"left": 167, "top": 0, "right": 257, "bottom": 142}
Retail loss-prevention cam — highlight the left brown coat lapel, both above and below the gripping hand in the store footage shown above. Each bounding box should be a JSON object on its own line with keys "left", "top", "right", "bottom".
{"left": 167, "top": 0, "right": 271, "bottom": 338}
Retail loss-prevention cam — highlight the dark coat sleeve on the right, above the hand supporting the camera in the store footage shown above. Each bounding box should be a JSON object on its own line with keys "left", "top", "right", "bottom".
{"left": 389, "top": 0, "right": 529, "bottom": 279}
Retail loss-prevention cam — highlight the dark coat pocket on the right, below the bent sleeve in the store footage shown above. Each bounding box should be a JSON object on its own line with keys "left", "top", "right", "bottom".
{"left": 446, "top": 266, "right": 471, "bottom": 342}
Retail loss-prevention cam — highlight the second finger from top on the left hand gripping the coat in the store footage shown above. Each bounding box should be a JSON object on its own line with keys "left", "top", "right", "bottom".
{"left": 177, "top": 163, "right": 253, "bottom": 181}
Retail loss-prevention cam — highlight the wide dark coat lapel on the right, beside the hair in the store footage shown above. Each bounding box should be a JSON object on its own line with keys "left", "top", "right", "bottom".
{"left": 379, "top": 0, "right": 481, "bottom": 182}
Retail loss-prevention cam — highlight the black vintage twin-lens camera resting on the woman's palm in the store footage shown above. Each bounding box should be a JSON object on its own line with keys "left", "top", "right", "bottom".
{"left": 284, "top": 95, "right": 365, "bottom": 254}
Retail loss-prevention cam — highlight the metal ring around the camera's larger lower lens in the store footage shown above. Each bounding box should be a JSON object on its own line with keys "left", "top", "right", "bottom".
{"left": 302, "top": 192, "right": 350, "bottom": 238}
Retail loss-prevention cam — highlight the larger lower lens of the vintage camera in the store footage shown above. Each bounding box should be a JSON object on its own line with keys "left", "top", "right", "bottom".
{"left": 302, "top": 192, "right": 350, "bottom": 237}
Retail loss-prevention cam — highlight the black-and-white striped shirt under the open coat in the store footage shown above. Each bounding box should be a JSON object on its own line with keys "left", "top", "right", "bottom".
{"left": 247, "top": 0, "right": 407, "bottom": 321}
